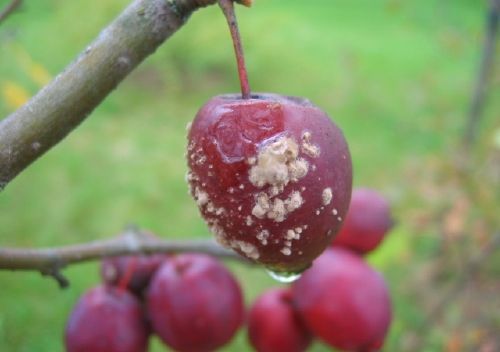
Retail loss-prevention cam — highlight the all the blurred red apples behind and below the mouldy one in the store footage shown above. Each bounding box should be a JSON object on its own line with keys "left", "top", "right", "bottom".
{"left": 65, "top": 189, "right": 392, "bottom": 352}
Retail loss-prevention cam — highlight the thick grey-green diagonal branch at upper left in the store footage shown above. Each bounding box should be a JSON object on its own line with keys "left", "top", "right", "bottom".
{"left": 0, "top": 0, "right": 224, "bottom": 190}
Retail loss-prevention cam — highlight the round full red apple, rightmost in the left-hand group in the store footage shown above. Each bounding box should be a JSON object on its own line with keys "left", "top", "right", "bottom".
{"left": 146, "top": 254, "right": 244, "bottom": 352}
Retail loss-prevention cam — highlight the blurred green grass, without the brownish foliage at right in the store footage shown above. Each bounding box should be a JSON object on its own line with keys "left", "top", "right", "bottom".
{"left": 0, "top": 0, "right": 494, "bottom": 352}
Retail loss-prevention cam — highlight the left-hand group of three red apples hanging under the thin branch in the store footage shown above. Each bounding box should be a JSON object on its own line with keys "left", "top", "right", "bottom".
{"left": 65, "top": 243, "right": 244, "bottom": 352}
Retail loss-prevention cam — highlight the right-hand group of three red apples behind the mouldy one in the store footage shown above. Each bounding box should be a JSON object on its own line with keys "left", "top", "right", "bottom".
{"left": 248, "top": 188, "right": 392, "bottom": 352}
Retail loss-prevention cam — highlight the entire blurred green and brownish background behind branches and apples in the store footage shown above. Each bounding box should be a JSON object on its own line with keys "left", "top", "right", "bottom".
{"left": 0, "top": 0, "right": 500, "bottom": 352}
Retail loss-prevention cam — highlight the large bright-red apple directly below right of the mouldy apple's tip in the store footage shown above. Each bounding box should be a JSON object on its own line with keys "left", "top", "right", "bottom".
{"left": 292, "top": 248, "right": 392, "bottom": 351}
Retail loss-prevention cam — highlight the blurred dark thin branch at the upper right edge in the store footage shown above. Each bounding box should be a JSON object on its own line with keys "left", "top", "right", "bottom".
{"left": 463, "top": 0, "right": 500, "bottom": 151}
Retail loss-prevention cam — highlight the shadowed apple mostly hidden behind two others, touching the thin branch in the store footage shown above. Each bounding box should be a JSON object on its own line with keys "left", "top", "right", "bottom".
{"left": 101, "top": 254, "right": 168, "bottom": 296}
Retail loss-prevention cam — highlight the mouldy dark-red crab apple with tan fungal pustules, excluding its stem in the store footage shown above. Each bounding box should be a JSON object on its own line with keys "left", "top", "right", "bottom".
{"left": 187, "top": 94, "right": 352, "bottom": 272}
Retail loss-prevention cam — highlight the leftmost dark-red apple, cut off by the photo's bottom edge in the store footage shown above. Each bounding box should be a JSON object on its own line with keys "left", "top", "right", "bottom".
{"left": 65, "top": 286, "right": 149, "bottom": 352}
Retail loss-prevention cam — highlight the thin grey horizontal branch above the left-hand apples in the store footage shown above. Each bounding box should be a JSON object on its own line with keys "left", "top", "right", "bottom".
{"left": 0, "top": 230, "right": 244, "bottom": 276}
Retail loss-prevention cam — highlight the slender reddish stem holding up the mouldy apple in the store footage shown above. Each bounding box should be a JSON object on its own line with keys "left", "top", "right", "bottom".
{"left": 219, "top": 0, "right": 250, "bottom": 99}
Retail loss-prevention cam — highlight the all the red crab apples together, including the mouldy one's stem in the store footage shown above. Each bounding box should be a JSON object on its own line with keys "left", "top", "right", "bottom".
{"left": 65, "top": 0, "right": 392, "bottom": 352}
